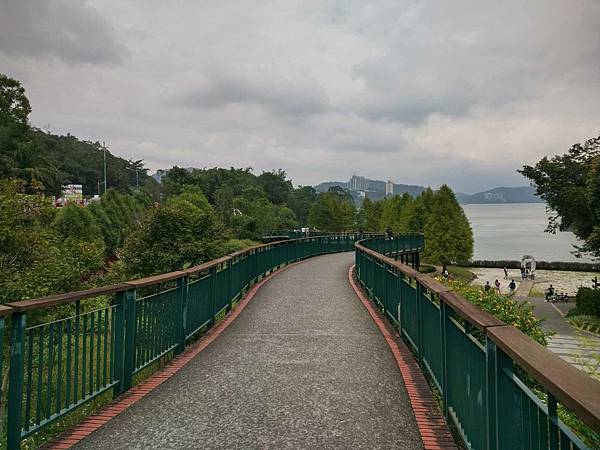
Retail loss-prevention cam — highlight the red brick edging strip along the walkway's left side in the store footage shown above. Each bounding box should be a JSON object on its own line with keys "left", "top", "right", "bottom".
{"left": 42, "top": 261, "right": 300, "bottom": 450}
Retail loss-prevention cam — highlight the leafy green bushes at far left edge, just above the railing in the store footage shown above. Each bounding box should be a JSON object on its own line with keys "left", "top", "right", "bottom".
{"left": 0, "top": 180, "right": 104, "bottom": 303}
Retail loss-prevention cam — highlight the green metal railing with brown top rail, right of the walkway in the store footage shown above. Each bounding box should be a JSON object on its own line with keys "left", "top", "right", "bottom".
{"left": 356, "top": 236, "right": 600, "bottom": 450}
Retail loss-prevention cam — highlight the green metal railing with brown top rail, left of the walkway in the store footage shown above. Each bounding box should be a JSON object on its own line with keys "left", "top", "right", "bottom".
{"left": 0, "top": 233, "right": 364, "bottom": 450}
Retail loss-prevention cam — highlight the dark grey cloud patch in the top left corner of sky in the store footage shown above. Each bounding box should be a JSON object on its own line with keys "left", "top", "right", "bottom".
{"left": 0, "top": 0, "right": 127, "bottom": 64}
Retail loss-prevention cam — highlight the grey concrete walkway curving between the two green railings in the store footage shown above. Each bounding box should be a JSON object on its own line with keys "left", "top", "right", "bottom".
{"left": 76, "top": 253, "right": 423, "bottom": 450}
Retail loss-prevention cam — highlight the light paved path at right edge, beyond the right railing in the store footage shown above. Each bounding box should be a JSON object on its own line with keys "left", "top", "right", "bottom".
{"left": 527, "top": 297, "right": 600, "bottom": 378}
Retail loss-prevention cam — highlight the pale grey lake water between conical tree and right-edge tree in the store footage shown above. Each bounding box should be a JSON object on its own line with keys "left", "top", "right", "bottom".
{"left": 462, "top": 203, "right": 591, "bottom": 262}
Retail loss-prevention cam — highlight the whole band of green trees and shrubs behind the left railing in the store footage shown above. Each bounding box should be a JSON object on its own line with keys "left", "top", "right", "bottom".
{"left": 0, "top": 75, "right": 473, "bottom": 302}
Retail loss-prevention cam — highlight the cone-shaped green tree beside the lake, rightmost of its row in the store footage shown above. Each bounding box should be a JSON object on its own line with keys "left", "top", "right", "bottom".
{"left": 423, "top": 184, "right": 473, "bottom": 264}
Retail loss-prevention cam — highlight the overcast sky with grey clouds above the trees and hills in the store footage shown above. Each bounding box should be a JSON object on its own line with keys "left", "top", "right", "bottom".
{"left": 0, "top": 0, "right": 600, "bottom": 192}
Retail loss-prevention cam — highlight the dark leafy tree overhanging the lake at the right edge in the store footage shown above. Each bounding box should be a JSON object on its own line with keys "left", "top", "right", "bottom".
{"left": 518, "top": 136, "right": 600, "bottom": 258}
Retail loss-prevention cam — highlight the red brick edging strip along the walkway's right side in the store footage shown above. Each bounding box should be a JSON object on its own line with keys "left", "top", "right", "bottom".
{"left": 348, "top": 266, "right": 458, "bottom": 450}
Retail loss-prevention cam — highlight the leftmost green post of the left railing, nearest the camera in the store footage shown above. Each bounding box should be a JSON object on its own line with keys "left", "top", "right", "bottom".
{"left": 6, "top": 312, "right": 25, "bottom": 450}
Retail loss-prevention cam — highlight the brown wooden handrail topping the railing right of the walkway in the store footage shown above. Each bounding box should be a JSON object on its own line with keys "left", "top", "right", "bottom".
{"left": 355, "top": 240, "right": 600, "bottom": 444}
